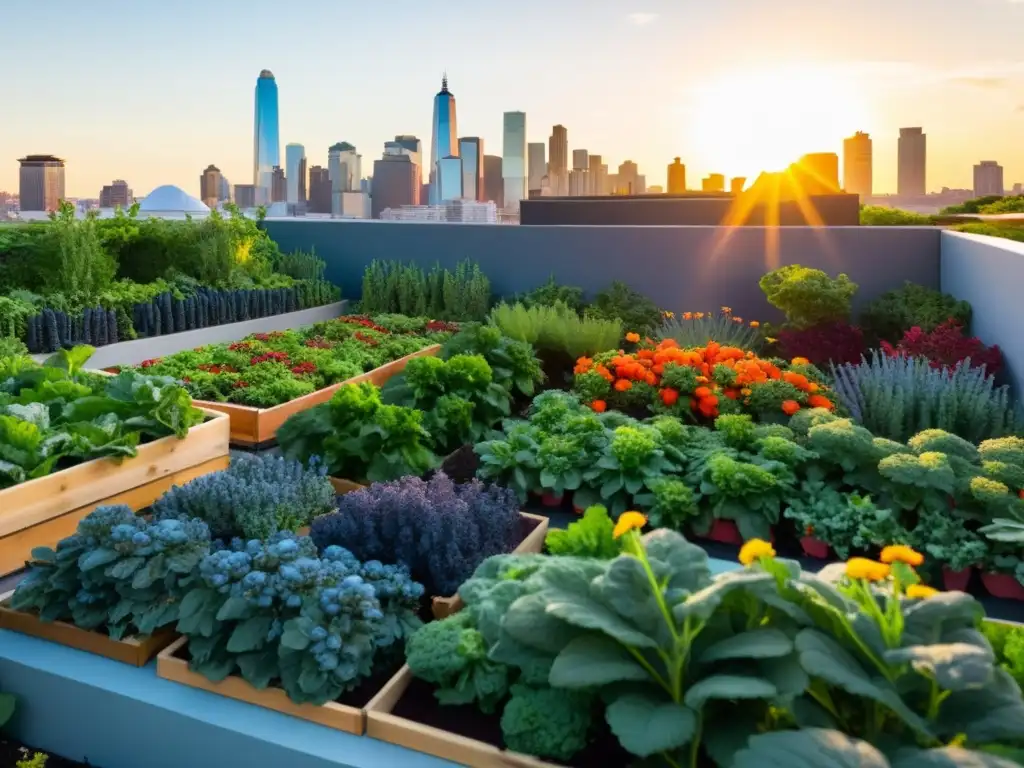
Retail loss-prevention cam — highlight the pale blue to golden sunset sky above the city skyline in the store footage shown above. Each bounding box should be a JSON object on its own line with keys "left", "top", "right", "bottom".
{"left": 6, "top": 0, "right": 1024, "bottom": 197}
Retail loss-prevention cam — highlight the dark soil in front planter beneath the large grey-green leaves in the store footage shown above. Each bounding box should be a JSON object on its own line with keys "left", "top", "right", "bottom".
{"left": 392, "top": 678, "right": 635, "bottom": 768}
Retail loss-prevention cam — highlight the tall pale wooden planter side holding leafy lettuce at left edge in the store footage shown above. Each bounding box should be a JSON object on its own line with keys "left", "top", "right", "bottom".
{"left": 0, "top": 409, "right": 229, "bottom": 575}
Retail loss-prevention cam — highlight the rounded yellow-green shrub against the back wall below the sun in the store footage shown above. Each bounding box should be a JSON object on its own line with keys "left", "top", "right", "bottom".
{"left": 759, "top": 264, "right": 857, "bottom": 329}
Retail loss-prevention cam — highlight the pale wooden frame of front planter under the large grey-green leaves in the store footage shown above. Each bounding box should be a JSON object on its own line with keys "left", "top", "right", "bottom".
{"left": 365, "top": 666, "right": 557, "bottom": 768}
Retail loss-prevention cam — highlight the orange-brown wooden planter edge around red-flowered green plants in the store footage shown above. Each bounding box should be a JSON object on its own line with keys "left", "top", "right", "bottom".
{"left": 196, "top": 344, "right": 441, "bottom": 447}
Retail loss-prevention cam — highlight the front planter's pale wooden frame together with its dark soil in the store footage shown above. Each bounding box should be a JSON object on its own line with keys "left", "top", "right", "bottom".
{"left": 366, "top": 667, "right": 635, "bottom": 768}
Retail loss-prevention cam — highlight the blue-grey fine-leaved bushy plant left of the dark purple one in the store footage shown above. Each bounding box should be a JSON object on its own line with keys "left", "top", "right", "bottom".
{"left": 153, "top": 454, "right": 335, "bottom": 540}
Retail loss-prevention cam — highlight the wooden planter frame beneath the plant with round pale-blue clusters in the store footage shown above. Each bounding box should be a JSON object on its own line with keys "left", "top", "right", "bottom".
{"left": 157, "top": 637, "right": 366, "bottom": 736}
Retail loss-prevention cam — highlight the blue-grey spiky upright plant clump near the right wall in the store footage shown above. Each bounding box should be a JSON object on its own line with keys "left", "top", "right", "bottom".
{"left": 833, "top": 351, "right": 1021, "bottom": 443}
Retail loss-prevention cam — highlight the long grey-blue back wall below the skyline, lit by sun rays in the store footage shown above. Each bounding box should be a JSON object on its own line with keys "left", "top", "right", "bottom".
{"left": 266, "top": 220, "right": 939, "bottom": 319}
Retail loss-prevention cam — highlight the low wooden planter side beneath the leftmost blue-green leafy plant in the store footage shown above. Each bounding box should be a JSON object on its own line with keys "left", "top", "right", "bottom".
{"left": 0, "top": 592, "right": 177, "bottom": 667}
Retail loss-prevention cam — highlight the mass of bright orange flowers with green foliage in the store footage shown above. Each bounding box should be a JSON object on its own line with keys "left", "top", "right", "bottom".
{"left": 573, "top": 339, "right": 833, "bottom": 421}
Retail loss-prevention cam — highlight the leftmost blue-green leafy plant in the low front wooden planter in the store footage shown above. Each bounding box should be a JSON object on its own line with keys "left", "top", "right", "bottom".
{"left": 11, "top": 505, "right": 210, "bottom": 639}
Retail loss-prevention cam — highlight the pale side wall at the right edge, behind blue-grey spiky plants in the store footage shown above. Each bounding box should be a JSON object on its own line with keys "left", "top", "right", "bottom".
{"left": 941, "top": 230, "right": 1024, "bottom": 392}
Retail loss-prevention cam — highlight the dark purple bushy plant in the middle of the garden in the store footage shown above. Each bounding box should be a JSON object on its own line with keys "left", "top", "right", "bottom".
{"left": 310, "top": 472, "right": 521, "bottom": 595}
